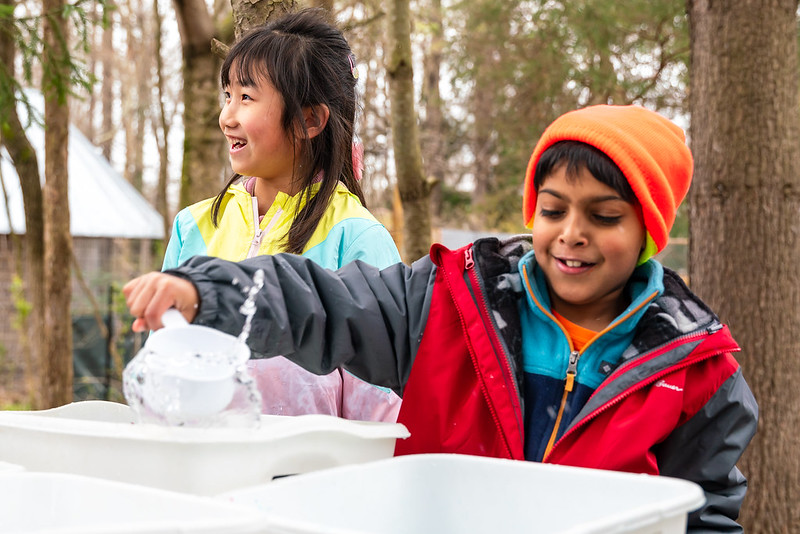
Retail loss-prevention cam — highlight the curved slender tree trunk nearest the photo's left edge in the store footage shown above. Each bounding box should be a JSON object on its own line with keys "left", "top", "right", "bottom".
{"left": 0, "top": 0, "right": 45, "bottom": 406}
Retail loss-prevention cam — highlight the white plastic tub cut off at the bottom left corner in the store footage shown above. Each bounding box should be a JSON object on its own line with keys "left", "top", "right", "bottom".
{"left": 0, "top": 473, "right": 263, "bottom": 534}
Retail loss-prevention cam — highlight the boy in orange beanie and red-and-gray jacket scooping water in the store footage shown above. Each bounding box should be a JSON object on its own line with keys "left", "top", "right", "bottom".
{"left": 124, "top": 106, "right": 757, "bottom": 532}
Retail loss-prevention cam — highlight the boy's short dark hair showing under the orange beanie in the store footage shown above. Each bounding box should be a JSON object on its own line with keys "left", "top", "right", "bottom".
{"left": 533, "top": 141, "right": 636, "bottom": 204}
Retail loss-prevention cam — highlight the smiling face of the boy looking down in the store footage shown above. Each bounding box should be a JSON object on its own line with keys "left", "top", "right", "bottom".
{"left": 533, "top": 164, "right": 645, "bottom": 331}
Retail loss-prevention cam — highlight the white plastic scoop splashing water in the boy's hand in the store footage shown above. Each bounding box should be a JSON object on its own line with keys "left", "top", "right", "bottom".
{"left": 123, "top": 309, "right": 250, "bottom": 424}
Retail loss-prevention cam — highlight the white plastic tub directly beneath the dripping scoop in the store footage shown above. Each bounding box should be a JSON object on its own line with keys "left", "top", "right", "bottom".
{"left": 0, "top": 401, "right": 409, "bottom": 495}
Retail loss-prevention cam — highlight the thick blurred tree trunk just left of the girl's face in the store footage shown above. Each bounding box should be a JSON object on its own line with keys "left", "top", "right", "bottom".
{"left": 173, "top": 0, "right": 225, "bottom": 208}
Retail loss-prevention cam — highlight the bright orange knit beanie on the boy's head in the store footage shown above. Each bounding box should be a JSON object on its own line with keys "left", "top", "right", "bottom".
{"left": 522, "top": 105, "right": 693, "bottom": 263}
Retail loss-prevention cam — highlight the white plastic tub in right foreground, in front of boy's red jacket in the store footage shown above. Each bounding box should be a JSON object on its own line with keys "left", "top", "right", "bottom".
{"left": 220, "top": 454, "right": 705, "bottom": 534}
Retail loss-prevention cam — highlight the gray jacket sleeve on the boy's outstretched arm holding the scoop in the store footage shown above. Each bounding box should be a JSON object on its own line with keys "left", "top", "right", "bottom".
{"left": 168, "top": 254, "right": 436, "bottom": 394}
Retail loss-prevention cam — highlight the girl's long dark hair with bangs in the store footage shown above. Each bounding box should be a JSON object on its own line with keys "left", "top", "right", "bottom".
{"left": 211, "top": 8, "right": 366, "bottom": 254}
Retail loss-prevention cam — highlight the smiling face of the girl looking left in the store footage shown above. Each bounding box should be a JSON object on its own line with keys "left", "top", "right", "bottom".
{"left": 219, "top": 69, "right": 295, "bottom": 191}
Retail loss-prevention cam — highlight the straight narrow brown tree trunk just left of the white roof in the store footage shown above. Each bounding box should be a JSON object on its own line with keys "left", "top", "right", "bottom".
{"left": 41, "top": 0, "right": 72, "bottom": 407}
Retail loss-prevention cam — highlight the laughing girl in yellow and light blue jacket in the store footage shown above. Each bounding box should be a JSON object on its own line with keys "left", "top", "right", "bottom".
{"left": 163, "top": 10, "right": 400, "bottom": 421}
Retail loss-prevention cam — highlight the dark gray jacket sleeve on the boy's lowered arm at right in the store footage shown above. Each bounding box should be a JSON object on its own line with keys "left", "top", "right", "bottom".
{"left": 657, "top": 369, "right": 758, "bottom": 534}
